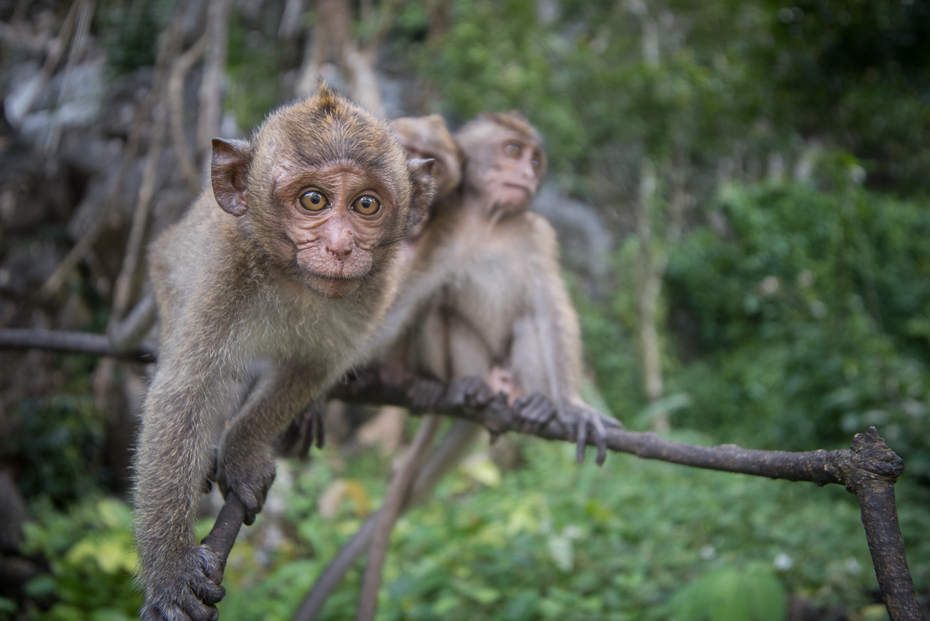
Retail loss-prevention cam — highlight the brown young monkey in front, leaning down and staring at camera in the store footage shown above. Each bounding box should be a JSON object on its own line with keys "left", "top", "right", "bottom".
{"left": 135, "top": 84, "right": 432, "bottom": 621}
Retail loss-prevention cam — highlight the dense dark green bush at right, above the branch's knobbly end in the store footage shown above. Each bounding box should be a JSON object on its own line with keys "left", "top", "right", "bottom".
{"left": 667, "top": 179, "right": 930, "bottom": 477}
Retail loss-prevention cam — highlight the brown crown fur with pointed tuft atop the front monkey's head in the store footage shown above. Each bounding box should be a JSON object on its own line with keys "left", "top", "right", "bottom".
{"left": 252, "top": 83, "right": 410, "bottom": 195}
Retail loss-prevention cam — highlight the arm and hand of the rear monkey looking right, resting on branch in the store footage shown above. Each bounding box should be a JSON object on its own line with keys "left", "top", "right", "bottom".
{"left": 511, "top": 214, "right": 622, "bottom": 464}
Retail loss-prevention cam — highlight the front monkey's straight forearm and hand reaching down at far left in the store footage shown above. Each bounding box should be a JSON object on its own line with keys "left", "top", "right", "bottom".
{"left": 135, "top": 352, "right": 232, "bottom": 621}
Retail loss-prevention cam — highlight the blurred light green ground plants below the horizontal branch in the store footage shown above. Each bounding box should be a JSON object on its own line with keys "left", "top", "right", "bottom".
{"left": 199, "top": 434, "right": 904, "bottom": 621}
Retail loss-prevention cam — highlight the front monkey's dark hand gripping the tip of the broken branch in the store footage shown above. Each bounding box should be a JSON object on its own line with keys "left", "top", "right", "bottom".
{"left": 216, "top": 434, "right": 275, "bottom": 526}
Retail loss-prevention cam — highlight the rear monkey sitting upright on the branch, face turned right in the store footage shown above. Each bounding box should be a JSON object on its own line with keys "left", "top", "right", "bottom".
{"left": 297, "top": 114, "right": 619, "bottom": 621}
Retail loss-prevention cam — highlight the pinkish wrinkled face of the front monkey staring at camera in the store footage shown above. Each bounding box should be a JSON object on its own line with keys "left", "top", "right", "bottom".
{"left": 275, "top": 162, "right": 396, "bottom": 298}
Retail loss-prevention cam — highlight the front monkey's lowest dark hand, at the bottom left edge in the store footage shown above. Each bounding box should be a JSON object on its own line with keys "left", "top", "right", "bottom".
{"left": 139, "top": 545, "right": 226, "bottom": 621}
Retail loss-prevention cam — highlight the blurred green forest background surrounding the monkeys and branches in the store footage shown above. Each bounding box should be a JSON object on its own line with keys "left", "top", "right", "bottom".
{"left": 0, "top": 0, "right": 930, "bottom": 621}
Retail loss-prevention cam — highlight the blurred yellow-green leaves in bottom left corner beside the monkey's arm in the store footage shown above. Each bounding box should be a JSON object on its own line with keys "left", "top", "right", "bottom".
{"left": 23, "top": 497, "right": 142, "bottom": 621}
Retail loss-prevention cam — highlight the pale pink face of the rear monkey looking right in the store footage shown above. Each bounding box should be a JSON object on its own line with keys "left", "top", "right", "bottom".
{"left": 481, "top": 132, "right": 543, "bottom": 208}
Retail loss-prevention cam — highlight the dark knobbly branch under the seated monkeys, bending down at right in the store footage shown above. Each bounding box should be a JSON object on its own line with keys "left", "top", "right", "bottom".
{"left": 320, "top": 372, "right": 923, "bottom": 621}
